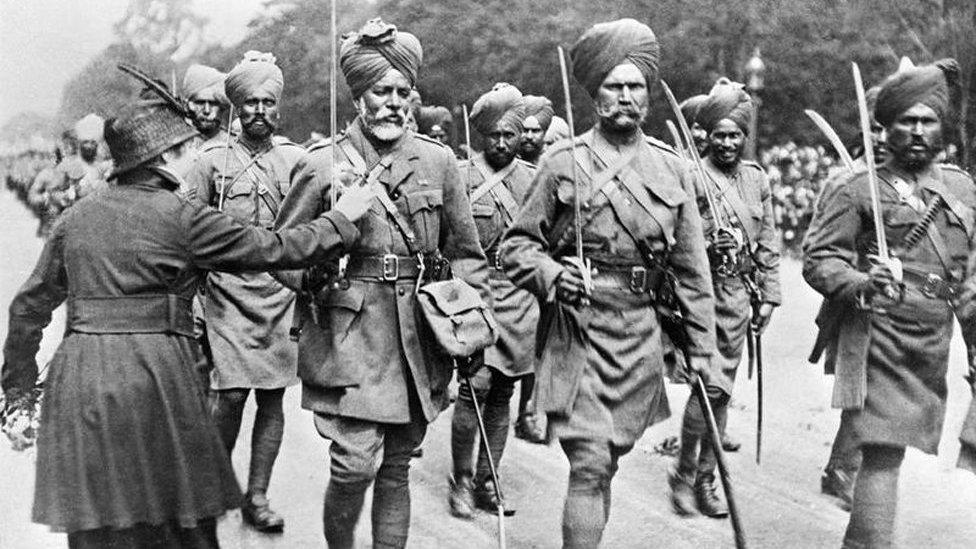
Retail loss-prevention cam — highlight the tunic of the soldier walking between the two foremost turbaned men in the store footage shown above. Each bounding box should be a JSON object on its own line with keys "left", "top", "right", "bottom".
{"left": 458, "top": 154, "right": 539, "bottom": 377}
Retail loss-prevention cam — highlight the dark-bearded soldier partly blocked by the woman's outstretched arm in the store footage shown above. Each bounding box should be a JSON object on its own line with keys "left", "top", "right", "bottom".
{"left": 186, "top": 51, "right": 305, "bottom": 532}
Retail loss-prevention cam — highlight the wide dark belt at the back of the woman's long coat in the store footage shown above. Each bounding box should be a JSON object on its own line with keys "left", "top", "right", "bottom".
{"left": 67, "top": 294, "right": 194, "bottom": 337}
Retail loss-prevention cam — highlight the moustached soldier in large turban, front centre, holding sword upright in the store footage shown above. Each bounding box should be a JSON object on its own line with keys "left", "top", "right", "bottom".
{"left": 501, "top": 19, "right": 715, "bottom": 547}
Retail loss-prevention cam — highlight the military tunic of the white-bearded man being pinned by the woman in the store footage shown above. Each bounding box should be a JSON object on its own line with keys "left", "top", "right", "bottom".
{"left": 277, "top": 121, "right": 491, "bottom": 424}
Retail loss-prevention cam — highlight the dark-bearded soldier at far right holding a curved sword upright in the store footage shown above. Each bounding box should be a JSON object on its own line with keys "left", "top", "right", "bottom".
{"left": 803, "top": 60, "right": 976, "bottom": 547}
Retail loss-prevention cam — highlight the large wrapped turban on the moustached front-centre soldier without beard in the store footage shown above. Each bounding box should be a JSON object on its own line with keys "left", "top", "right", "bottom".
{"left": 569, "top": 19, "right": 661, "bottom": 97}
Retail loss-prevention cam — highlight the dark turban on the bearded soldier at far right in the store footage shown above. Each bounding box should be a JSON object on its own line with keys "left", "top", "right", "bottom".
{"left": 874, "top": 59, "right": 959, "bottom": 126}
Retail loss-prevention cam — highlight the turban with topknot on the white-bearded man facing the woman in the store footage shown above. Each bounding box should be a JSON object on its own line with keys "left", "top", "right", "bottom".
{"left": 339, "top": 19, "right": 424, "bottom": 98}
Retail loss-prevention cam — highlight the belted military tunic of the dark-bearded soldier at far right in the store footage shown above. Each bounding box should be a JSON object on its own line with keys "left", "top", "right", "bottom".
{"left": 803, "top": 161, "right": 976, "bottom": 453}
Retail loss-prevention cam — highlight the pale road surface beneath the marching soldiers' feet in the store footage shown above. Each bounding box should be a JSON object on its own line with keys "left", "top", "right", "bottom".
{"left": 0, "top": 186, "right": 976, "bottom": 549}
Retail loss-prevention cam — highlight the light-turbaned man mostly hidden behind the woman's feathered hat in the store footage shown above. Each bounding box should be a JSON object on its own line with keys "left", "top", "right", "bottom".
{"left": 182, "top": 64, "right": 228, "bottom": 150}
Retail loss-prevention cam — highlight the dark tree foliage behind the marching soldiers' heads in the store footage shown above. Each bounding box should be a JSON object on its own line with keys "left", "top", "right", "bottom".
{"left": 49, "top": 0, "right": 976, "bottom": 167}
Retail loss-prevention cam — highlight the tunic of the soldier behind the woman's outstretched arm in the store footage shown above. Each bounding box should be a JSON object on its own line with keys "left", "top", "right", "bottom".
{"left": 186, "top": 140, "right": 305, "bottom": 390}
